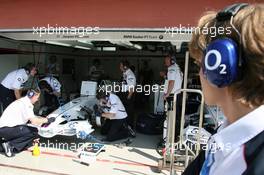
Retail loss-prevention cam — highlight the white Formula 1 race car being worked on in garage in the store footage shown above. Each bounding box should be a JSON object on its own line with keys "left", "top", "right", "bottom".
{"left": 39, "top": 96, "right": 96, "bottom": 138}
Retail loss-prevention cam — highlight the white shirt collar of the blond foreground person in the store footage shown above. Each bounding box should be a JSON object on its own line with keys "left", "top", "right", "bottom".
{"left": 212, "top": 105, "right": 264, "bottom": 156}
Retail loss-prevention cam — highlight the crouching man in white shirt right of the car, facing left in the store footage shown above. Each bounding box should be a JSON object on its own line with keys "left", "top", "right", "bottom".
{"left": 96, "top": 90, "right": 133, "bottom": 141}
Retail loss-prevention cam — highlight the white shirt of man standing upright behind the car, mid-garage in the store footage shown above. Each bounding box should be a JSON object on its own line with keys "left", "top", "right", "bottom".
{"left": 122, "top": 69, "right": 137, "bottom": 92}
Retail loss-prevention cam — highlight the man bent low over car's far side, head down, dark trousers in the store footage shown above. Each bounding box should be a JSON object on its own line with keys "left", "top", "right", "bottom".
{"left": 38, "top": 76, "right": 62, "bottom": 115}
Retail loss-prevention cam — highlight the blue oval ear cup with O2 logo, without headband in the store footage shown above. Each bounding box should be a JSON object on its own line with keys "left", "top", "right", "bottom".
{"left": 202, "top": 38, "right": 239, "bottom": 87}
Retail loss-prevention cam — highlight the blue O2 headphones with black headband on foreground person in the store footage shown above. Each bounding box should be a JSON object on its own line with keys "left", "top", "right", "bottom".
{"left": 202, "top": 3, "right": 248, "bottom": 87}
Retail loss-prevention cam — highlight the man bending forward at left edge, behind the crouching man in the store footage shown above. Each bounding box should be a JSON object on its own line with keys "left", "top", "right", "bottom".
{"left": 0, "top": 63, "right": 37, "bottom": 110}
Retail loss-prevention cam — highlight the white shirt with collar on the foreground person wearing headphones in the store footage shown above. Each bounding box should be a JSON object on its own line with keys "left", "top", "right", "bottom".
{"left": 203, "top": 106, "right": 264, "bottom": 175}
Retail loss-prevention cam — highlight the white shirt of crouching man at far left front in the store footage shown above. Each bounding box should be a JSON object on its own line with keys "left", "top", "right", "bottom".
{"left": 0, "top": 96, "right": 35, "bottom": 128}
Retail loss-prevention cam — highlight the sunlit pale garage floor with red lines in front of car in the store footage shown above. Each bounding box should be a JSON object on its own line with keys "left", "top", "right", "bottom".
{"left": 0, "top": 129, "right": 182, "bottom": 175}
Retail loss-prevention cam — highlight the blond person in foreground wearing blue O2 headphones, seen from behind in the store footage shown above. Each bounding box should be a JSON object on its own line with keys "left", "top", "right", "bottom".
{"left": 183, "top": 3, "right": 264, "bottom": 175}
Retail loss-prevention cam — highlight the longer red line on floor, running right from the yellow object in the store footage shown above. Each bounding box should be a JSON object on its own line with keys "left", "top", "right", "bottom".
{"left": 27, "top": 150, "right": 157, "bottom": 168}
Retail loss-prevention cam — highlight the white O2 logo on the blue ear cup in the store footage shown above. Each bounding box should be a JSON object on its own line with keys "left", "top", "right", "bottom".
{"left": 204, "top": 50, "right": 227, "bottom": 74}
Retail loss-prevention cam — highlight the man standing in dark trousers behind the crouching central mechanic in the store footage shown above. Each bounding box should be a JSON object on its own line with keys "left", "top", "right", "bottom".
{"left": 118, "top": 60, "right": 136, "bottom": 128}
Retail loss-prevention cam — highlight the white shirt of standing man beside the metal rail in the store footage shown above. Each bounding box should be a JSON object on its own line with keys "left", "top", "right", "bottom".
{"left": 164, "top": 63, "right": 183, "bottom": 94}
